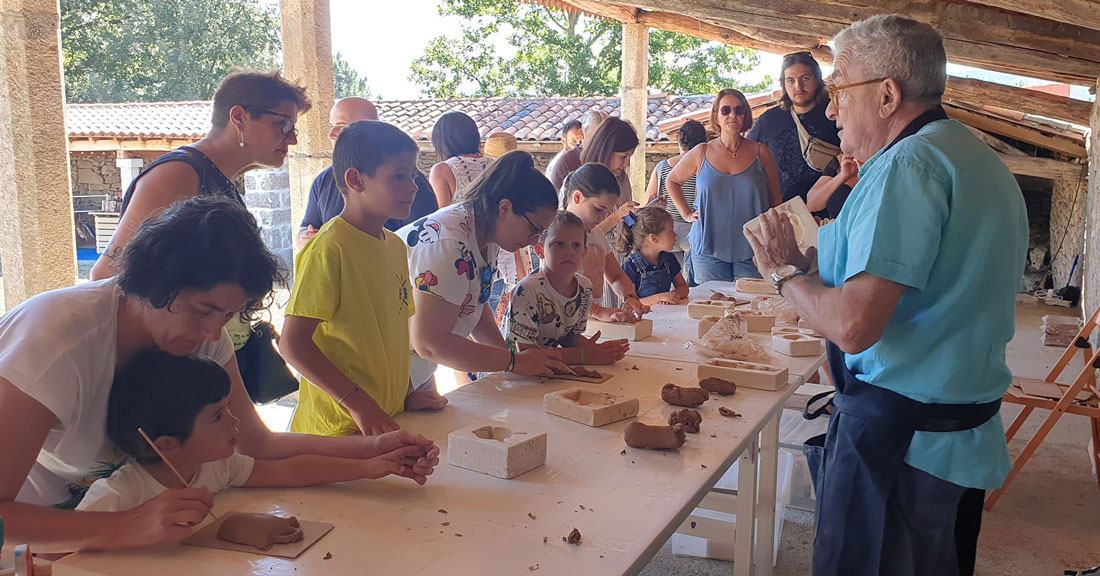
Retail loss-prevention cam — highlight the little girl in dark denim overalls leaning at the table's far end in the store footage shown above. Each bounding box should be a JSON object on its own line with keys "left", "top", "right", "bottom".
{"left": 615, "top": 206, "right": 688, "bottom": 306}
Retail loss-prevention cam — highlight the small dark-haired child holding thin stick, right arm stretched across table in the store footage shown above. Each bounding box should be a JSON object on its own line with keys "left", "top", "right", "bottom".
{"left": 77, "top": 351, "right": 439, "bottom": 512}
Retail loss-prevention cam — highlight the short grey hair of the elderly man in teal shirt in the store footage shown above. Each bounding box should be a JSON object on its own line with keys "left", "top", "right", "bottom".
{"left": 833, "top": 14, "right": 947, "bottom": 107}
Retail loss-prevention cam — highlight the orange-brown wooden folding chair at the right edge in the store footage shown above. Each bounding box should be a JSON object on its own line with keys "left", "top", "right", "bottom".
{"left": 986, "top": 308, "right": 1100, "bottom": 510}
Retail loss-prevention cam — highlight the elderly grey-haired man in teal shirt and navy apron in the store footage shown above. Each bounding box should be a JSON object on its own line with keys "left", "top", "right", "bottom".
{"left": 746, "top": 15, "right": 1027, "bottom": 576}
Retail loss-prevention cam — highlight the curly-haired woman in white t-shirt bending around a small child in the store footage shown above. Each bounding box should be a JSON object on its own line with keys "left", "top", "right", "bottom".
{"left": 0, "top": 197, "right": 433, "bottom": 553}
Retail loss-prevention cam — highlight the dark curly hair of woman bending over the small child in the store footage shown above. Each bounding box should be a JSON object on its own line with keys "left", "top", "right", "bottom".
{"left": 118, "top": 196, "right": 287, "bottom": 321}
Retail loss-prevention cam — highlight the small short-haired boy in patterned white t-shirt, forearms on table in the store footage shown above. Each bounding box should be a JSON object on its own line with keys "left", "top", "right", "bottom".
{"left": 504, "top": 211, "right": 629, "bottom": 364}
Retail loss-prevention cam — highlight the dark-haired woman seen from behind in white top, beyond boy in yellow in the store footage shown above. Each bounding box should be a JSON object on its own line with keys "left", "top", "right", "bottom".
{"left": 428, "top": 112, "right": 490, "bottom": 208}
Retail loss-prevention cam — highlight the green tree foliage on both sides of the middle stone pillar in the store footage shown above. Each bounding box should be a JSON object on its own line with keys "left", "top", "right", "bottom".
{"left": 410, "top": 0, "right": 771, "bottom": 98}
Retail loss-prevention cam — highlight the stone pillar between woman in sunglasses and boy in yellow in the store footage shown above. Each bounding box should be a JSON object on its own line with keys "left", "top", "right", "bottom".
{"left": 279, "top": 0, "right": 334, "bottom": 259}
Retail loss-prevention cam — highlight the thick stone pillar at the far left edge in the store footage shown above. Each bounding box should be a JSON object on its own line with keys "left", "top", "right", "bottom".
{"left": 0, "top": 0, "right": 76, "bottom": 310}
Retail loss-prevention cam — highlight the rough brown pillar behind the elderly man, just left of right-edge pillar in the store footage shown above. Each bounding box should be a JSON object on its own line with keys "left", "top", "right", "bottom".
{"left": 1051, "top": 178, "right": 1088, "bottom": 288}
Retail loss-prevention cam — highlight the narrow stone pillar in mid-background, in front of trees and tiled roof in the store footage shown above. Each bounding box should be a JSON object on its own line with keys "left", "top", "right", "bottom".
{"left": 619, "top": 22, "right": 649, "bottom": 200}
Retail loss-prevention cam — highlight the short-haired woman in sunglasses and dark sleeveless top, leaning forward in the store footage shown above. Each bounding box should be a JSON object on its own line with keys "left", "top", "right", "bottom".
{"left": 91, "top": 71, "right": 310, "bottom": 280}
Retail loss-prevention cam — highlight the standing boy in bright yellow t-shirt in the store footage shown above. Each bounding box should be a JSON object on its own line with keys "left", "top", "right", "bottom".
{"left": 279, "top": 121, "right": 446, "bottom": 436}
